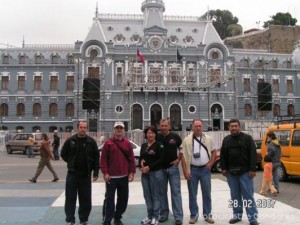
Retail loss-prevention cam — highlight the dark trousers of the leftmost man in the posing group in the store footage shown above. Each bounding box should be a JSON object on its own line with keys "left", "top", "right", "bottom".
{"left": 65, "top": 173, "right": 92, "bottom": 223}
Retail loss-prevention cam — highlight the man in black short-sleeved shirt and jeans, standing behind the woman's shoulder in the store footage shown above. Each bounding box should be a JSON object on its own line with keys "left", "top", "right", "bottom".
{"left": 156, "top": 119, "right": 183, "bottom": 225}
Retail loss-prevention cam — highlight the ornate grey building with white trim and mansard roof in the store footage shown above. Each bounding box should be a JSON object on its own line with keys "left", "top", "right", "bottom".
{"left": 0, "top": 0, "right": 300, "bottom": 131}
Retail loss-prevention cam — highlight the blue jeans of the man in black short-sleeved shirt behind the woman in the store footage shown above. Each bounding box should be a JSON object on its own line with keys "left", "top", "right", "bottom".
{"left": 160, "top": 166, "right": 183, "bottom": 221}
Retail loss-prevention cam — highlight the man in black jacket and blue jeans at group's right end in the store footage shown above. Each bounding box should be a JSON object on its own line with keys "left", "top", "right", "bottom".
{"left": 220, "top": 119, "right": 258, "bottom": 225}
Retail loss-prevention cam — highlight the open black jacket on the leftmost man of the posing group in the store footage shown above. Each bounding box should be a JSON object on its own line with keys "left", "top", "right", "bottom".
{"left": 60, "top": 134, "right": 99, "bottom": 177}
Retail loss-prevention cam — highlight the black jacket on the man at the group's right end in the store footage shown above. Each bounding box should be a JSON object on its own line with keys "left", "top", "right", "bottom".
{"left": 220, "top": 132, "right": 257, "bottom": 172}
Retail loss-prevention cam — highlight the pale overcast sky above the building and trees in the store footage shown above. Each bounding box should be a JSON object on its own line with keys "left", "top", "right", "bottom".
{"left": 0, "top": 0, "right": 300, "bottom": 48}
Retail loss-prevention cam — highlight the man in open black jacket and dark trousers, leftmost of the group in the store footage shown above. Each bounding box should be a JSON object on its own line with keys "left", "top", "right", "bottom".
{"left": 60, "top": 121, "right": 99, "bottom": 225}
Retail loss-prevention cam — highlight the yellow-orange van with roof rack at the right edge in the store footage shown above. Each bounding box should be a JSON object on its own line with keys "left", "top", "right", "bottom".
{"left": 261, "top": 115, "right": 300, "bottom": 181}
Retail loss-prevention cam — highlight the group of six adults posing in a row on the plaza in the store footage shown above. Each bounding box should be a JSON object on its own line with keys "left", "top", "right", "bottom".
{"left": 28, "top": 119, "right": 279, "bottom": 225}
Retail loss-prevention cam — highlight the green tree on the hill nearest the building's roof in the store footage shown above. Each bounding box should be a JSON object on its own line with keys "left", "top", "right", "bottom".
{"left": 201, "top": 9, "right": 243, "bottom": 39}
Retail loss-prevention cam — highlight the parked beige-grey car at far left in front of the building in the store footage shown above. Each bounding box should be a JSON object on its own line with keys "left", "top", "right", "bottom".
{"left": 6, "top": 133, "right": 42, "bottom": 154}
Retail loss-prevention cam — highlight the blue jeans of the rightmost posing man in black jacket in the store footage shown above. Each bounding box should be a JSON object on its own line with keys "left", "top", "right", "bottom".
{"left": 227, "top": 172, "right": 258, "bottom": 223}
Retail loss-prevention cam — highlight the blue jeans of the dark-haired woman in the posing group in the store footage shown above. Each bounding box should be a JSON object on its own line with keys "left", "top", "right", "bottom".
{"left": 142, "top": 170, "right": 163, "bottom": 219}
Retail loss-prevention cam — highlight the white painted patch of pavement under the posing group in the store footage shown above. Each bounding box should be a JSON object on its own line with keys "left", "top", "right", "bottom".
{"left": 52, "top": 179, "right": 300, "bottom": 225}
